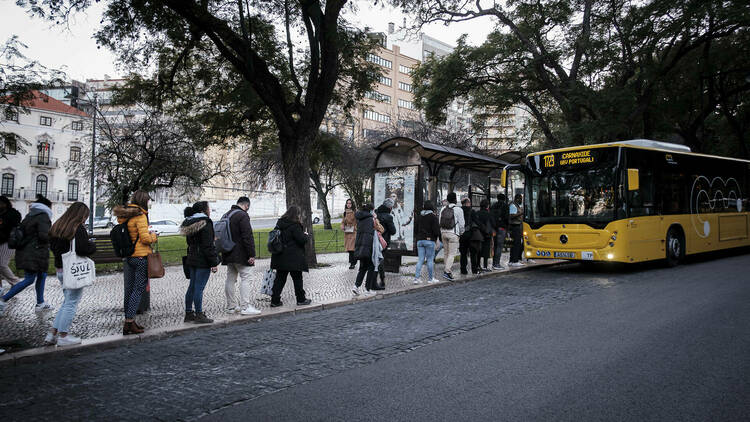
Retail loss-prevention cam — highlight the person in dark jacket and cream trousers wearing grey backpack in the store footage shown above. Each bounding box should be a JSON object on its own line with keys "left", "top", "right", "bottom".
{"left": 220, "top": 196, "right": 260, "bottom": 315}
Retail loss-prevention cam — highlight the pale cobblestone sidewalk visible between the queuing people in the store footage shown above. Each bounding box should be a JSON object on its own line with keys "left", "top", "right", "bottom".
{"left": 0, "top": 253, "right": 524, "bottom": 352}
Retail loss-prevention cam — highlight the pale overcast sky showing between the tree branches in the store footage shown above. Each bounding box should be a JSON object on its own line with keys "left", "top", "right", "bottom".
{"left": 0, "top": 0, "right": 500, "bottom": 81}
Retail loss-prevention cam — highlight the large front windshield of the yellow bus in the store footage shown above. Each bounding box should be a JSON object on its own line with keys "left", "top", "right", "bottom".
{"left": 524, "top": 150, "right": 617, "bottom": 228}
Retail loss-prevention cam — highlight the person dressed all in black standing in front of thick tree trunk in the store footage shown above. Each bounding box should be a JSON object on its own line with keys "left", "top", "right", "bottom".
{"left": 271, "top": 205, "right": 312, "bottom": 308}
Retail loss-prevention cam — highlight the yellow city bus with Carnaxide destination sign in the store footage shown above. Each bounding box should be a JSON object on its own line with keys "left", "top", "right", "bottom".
{"left": 503, "top": 140, "right": 750, "bottom": 266}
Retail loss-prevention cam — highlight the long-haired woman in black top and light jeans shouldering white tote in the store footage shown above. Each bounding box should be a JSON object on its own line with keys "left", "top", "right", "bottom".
{"left": 44, "top": 202, "right": 96, "bottom": 347}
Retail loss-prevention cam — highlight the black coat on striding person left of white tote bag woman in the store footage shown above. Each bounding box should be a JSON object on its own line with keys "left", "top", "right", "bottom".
{"left": 16, "top": 202, "right": 52, "bottom": 273}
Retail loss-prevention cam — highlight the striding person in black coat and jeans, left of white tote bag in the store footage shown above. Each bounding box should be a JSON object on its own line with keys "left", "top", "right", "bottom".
{"left": 0, "top": 195, "right": 52, "bottom": 315}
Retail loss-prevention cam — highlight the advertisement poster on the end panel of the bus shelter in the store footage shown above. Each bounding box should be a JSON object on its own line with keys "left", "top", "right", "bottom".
{"left": 375, "top": 166, "right": 417, "bottom": 251}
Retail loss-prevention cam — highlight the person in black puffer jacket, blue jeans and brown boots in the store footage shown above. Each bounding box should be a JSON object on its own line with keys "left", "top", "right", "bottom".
{"left": 180, "top": 201, "right": 219, "bottom": 324}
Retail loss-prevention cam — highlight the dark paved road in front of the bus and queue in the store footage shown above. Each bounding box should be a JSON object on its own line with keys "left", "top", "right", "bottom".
{"left": 0, "top": 251, "right": 750, "bottom": 421}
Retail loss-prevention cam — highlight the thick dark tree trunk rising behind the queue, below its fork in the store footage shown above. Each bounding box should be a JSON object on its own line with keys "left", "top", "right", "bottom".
{"left": 279, "top": 134, "right": 318, "bottom": 267}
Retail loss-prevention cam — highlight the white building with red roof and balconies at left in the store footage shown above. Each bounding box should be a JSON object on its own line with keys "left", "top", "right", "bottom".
{"left": 0, "top": 93, "right": 91, "bottom": 218}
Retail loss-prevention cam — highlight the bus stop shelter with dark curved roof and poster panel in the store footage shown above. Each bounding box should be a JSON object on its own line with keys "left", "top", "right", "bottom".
{"left": 372, "top": 137, "right": 509, "bottom": 272}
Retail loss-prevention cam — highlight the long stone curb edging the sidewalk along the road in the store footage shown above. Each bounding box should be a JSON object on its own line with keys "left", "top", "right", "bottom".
{"left": 0, "top": 261, "right": 571, "bottom": 367}
